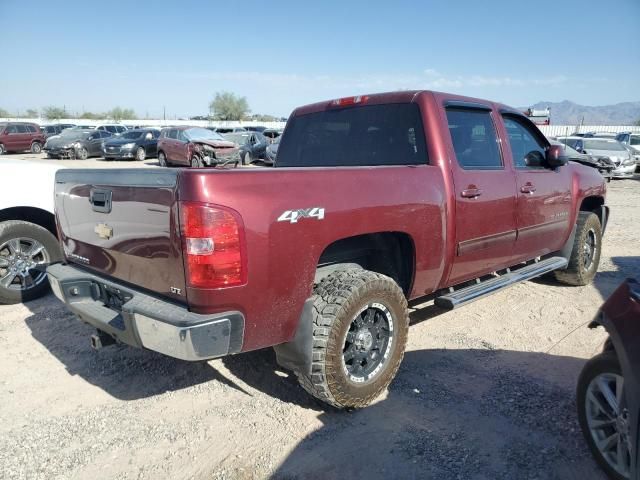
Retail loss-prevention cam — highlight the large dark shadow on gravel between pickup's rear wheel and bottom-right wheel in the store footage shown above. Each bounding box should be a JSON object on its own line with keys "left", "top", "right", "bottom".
{"left": 258, "top": 346, "right": 605, "bottom": 480}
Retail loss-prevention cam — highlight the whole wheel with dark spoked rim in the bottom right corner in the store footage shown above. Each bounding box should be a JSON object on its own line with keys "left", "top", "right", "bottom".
{"left": 577, "top": 352, "right": 631, "bottom": 480}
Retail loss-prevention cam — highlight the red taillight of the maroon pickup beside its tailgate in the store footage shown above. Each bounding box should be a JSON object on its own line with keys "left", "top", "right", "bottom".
{"left": 180, "top": 202, "right": 247, "bottom": 288}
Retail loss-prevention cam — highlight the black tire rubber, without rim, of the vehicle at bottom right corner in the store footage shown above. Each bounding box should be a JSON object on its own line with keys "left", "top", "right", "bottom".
{"left": 576, "top": 351, "right": 625, "bottom": 480}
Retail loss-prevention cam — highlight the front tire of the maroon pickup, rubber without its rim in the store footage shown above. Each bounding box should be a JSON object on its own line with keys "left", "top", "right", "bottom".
{"left": 554, "top": 212, "right": 602, "bottom": 286}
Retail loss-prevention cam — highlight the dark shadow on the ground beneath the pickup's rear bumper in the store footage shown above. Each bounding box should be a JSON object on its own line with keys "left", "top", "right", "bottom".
{"left": 25, "top": 295, "right": 247, "bottom": 400}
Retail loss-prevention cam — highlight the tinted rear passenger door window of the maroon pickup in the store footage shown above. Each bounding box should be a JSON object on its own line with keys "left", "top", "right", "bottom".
{"left": 447, "top": 108, "right": 503, "bottom": 170}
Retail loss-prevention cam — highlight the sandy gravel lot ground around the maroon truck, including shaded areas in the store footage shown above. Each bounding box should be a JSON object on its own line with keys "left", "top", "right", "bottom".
{"left": 0, "top": 156, "right": 640, "bottom": 480}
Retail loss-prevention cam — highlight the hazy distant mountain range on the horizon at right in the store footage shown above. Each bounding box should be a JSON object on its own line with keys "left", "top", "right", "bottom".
{"left": 522, "top": 100, "right": 640, "bottom": 125}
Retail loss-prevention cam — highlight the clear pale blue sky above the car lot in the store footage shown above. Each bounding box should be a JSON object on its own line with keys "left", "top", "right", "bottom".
{"left": 0, "top": 0, "right": 640, "bottom": 118}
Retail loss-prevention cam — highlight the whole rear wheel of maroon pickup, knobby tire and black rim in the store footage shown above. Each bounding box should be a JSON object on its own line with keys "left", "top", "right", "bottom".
{"left": 297, "top": 268, "right": 409, "bottom": 408}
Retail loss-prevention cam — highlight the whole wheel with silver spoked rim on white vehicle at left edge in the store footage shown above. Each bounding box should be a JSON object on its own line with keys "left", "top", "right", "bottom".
{"left": 0, "top": 220, "right": 62, "bottom": 304}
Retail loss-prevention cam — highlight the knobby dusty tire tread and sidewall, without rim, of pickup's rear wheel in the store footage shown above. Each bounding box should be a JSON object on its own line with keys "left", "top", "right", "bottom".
{"left": 296, "top": 268, "right": 409, "bottom": 408}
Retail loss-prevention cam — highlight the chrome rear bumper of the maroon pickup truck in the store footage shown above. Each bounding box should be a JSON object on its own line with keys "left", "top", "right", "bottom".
{"left": 47, "top": 263, "right": 244, "bottom": 361}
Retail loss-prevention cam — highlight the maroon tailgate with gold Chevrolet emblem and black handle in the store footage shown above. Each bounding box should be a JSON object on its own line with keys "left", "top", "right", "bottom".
{"left": 55, "top": 169, "right": 186, "bottom": 302}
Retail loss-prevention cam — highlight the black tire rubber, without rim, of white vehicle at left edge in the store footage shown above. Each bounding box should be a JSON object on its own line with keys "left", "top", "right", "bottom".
{"left": 0, "top": 220, "right": 62, "bottom": 305}
